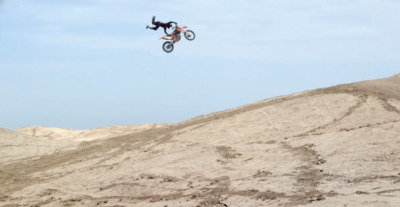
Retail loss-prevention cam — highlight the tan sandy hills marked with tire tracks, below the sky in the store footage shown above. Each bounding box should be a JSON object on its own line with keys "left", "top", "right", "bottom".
{"left": 0, "top": 75, "right": 400, "bottom": 207}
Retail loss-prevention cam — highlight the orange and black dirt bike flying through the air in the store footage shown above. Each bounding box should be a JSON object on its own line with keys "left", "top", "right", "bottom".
{"left": 160, "top": 25, "right": 196, "bottom": 53}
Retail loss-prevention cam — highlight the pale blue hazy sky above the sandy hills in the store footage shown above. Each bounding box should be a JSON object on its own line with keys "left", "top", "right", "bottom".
{"left": 0, "top": 0, "right": 400, "bottom": 129}
